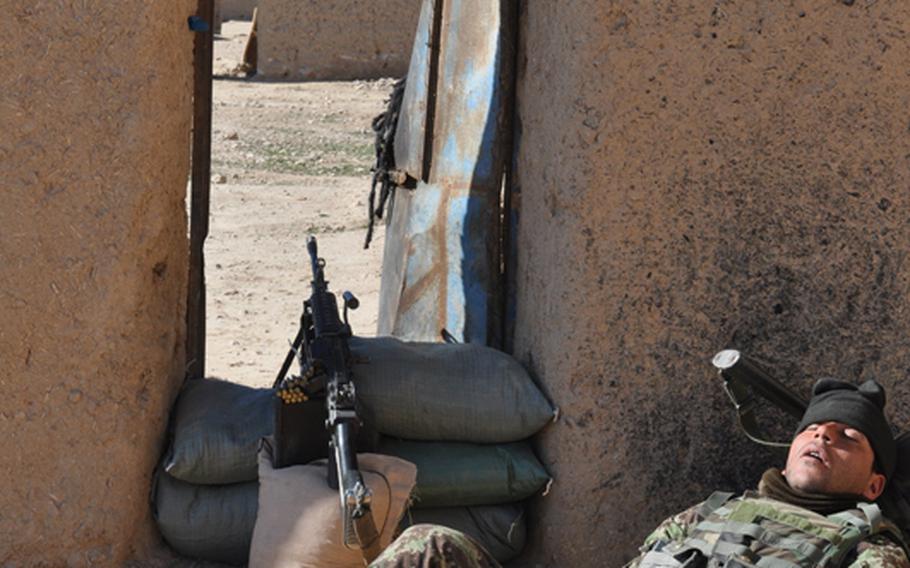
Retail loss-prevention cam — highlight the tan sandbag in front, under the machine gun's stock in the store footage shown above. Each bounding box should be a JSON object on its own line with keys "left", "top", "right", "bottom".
{"left": 250, "top": 440, "right": 417, "bottom": 568}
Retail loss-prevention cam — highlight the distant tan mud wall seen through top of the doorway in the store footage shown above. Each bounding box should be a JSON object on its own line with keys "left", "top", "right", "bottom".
{"left": 257, "top": 0, "right": 421, "bottom": 80}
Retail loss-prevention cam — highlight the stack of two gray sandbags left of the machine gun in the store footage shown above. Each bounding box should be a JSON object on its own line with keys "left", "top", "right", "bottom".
{"left": 153, "top": 379, "right": 274, "bottom": 564}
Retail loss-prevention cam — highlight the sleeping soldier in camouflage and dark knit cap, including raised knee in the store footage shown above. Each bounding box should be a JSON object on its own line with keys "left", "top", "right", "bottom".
{"left": 371, "top": 379, "right": 910, "bottom": 568}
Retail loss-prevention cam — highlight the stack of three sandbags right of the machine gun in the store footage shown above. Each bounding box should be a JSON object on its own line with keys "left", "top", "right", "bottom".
{"left": 351, "top": 337, "right": 555, "bottom": 562}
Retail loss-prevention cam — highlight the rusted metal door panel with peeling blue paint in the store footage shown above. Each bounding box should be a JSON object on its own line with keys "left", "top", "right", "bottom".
{"left": 379, "top": 0, "right": 515, "bottom": 346}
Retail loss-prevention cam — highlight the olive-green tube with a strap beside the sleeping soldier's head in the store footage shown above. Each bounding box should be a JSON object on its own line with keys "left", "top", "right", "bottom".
{"left": 711, "top": 349, "right": 807, "bottom": 447}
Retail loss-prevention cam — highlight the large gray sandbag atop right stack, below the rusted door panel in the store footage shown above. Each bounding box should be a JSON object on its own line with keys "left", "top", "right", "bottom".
{"left": 350, "top": 337, "right": 554, "bottom": 444}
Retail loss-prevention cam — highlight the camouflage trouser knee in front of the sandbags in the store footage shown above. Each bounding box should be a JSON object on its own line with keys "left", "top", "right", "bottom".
{"left": 369, "top": 525, "right": 500, "bottom": 568}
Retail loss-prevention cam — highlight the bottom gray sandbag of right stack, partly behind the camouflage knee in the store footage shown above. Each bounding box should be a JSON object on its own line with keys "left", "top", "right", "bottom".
{"left": 401, "top": 503, "right": 528, "bottom": 562}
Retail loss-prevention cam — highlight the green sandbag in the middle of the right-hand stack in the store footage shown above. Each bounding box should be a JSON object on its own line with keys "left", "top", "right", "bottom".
{"left": 379, "top": 438, "right": 550, "bottom": 508}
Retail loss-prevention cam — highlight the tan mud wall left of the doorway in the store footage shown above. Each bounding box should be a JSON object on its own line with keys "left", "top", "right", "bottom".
{"left": 0, "top": 0, "right": 195, "bottom": 566}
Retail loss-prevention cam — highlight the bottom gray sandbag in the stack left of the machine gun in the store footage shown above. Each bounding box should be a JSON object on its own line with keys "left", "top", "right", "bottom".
{"left": 154, "top": 472, "right": 259, "bottom": 565}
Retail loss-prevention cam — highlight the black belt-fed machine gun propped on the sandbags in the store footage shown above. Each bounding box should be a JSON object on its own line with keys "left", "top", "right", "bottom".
{"left": 275, "top": 236, "right": 380, "bottom": 562}
